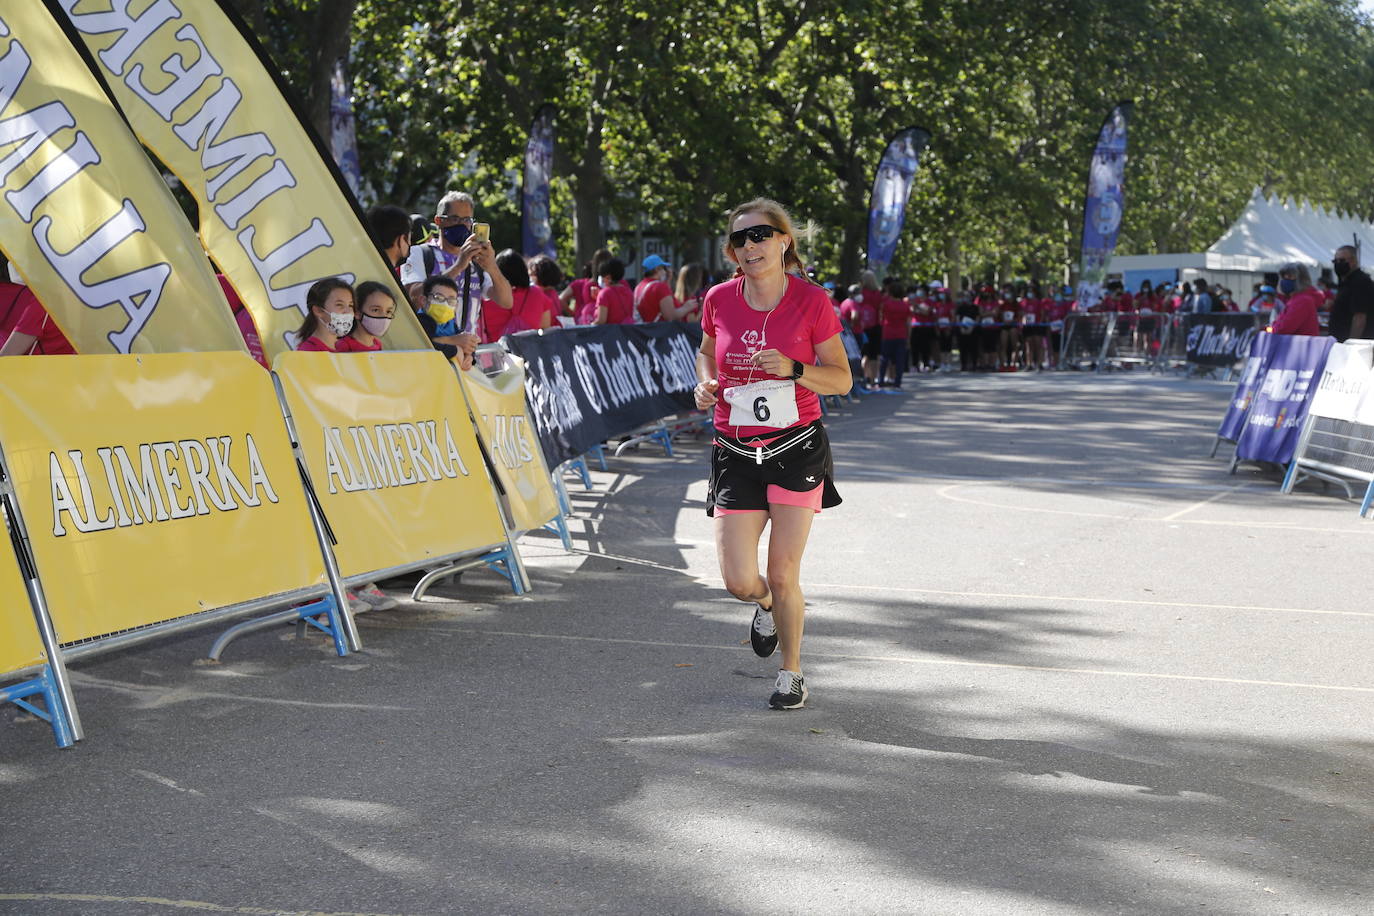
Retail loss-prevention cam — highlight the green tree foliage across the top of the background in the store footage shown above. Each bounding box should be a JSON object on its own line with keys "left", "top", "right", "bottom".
{"left": 247, "top": 0, "right": 1374, "bottom": 287}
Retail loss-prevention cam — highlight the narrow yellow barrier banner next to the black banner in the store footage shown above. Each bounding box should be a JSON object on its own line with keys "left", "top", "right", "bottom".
{"left": 458, "top": 356, "right": 559, "bottom": 531}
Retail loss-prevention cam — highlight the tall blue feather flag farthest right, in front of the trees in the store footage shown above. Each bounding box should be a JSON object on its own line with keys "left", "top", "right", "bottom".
{"left": 1074, "top": 102, "right": 1131, "bottom": 312}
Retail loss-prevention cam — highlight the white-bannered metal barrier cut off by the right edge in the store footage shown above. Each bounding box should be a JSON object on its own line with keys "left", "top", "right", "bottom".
{"left": 1282, "top": 338, "right": 1374, "bottom": 505}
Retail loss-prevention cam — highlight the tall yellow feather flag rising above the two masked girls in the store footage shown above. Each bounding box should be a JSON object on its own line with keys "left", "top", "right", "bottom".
{"left": 58, "top": 0, "right": 430, "bottom": 360}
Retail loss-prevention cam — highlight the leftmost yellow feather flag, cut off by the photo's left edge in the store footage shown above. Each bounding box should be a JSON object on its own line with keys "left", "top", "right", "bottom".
{"left": 0, "top": 3, "right": 243, "bottom": 353}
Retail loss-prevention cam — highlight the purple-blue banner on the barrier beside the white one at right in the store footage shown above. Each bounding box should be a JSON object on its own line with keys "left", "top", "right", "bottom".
{"left": 1235, "top": 334, "right": 1334, "bottom": 464}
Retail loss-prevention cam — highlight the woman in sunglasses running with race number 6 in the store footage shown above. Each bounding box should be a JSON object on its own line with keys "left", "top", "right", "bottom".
{"left": 695, "top": 198, "right": 852, "bottom": 709}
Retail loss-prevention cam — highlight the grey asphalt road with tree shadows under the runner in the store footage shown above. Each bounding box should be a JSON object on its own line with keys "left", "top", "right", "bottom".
{"left": 0, "top": 374, "right": 1374, "bottom": 916}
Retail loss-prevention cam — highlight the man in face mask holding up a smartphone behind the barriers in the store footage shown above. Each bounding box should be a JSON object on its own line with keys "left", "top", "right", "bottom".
{"left": 401, "top": 191, "right": 514, "bottom": 369}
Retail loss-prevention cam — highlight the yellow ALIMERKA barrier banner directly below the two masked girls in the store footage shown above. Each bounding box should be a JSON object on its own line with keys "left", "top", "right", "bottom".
{"left": 273, "top": 349, "right": 506, "bottom": 575}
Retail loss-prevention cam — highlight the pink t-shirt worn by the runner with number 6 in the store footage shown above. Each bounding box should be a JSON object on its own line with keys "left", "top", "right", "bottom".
{"left": 701, "top": 273, "right": 840, "bottom": 438}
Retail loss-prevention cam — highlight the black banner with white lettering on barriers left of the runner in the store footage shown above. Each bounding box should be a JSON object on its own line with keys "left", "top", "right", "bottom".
{"left": 502, "top": 321, "right": 701, "bottom": 468}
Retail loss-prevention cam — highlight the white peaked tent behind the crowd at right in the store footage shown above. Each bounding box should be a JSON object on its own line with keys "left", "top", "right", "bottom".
{"left": 1110, "top": 188, "right": 1374, "bottom": 295}
